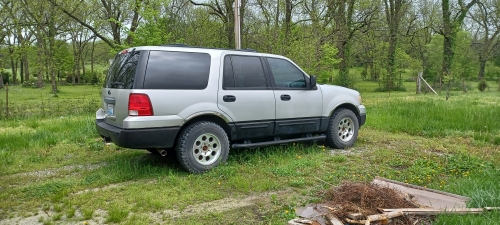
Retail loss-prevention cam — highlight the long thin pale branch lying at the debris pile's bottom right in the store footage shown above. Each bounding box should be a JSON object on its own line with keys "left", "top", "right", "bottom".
{"left": 382, "top": 207, "right": 492, "bottom": 216}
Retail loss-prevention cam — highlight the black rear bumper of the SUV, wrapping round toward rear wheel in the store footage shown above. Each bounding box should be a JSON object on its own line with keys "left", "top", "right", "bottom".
{"left": 95, "top": 119, "right": 180, "bottom": 149}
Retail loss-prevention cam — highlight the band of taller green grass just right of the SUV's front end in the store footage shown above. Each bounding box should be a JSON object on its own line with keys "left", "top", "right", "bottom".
{"left": 364, "top": 93, "right": 500, "bottom": 144}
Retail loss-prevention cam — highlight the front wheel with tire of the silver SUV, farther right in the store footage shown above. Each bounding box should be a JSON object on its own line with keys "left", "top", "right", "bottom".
{"left": 326, "top": 109, "right": 359, "bottom": 149}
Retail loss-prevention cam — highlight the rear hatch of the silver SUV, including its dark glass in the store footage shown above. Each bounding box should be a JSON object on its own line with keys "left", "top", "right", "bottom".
{"left": 101, "top": 49, "right": 142, "bottom": 128}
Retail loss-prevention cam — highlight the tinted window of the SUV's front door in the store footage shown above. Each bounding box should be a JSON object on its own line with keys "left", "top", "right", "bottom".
{"left": 267, "top": 58, "right": 307, "bottom": 88}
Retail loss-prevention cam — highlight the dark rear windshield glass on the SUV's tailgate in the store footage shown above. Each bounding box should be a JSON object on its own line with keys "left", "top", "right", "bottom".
{"left": 104, "top": 51, "right": 141, "bottom": 89}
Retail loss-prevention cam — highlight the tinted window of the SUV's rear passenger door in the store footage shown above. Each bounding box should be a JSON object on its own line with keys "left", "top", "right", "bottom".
{"left": 223, "top": 55, "right": 267, "bottom": 89}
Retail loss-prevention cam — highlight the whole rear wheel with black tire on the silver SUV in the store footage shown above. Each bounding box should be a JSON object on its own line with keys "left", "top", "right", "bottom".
{"left": 176, "top": 121, "right": 229, "bottom": 173}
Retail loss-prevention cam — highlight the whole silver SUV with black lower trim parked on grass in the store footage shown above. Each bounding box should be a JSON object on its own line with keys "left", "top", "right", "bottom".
{"left": 96, "top": 46, "right": 366, "bottom": 173}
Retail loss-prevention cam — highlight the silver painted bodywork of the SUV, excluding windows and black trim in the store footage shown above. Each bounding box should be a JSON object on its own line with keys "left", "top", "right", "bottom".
{"left": 96, "top": 46, "right": 366, "bottom": 129}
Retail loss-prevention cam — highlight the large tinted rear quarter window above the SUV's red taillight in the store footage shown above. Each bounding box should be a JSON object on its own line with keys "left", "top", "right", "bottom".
{"left": 144, "top": 51, "right": 210, "bottom": 90}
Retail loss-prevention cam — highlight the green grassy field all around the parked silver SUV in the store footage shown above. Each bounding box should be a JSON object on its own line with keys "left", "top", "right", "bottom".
{"left": 0, "top": 82, "right": 500, "bottom": 224}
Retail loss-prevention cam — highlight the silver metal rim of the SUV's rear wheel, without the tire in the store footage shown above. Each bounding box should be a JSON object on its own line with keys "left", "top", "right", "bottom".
{"left": 193, "top": 133, "right": 221, "bottom": 165}
